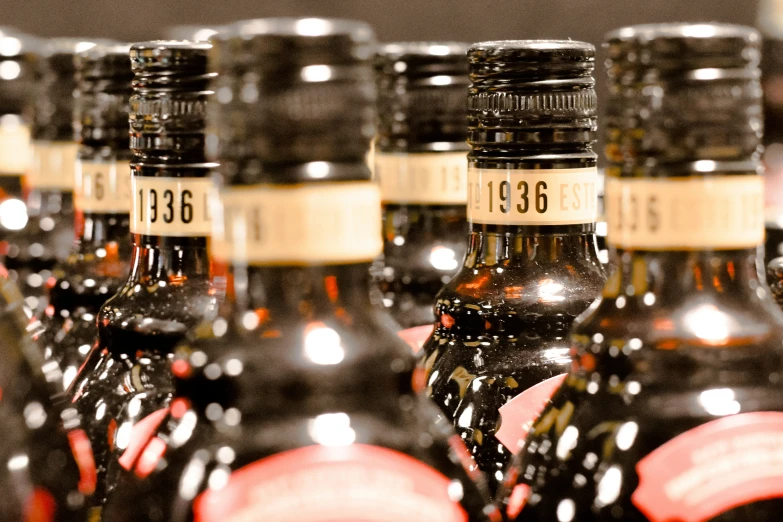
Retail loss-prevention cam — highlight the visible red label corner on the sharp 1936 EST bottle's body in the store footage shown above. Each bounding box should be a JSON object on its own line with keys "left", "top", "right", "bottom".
{"left": 495, "top": 373, "right": 567, "bottom": 455}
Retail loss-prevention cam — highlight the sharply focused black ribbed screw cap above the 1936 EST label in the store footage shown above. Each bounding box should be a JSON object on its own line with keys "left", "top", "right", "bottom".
{"left": 468, "top": 40, "right": 597, "bottom": 139}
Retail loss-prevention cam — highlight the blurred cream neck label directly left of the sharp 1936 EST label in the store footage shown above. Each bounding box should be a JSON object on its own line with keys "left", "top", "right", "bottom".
{"left": 375, "top": 152, "right": 468, "bottom": 205}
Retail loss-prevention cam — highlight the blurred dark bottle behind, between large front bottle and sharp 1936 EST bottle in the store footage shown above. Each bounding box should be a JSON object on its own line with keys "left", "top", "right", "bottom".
{"left": 373, "top": 42, "right": 468, "bottom": 332}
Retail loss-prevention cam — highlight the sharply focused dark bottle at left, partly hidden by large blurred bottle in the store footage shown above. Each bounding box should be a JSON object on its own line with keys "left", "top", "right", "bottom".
{"left": 69, "top": 41, "right": 216, "bottom": 510}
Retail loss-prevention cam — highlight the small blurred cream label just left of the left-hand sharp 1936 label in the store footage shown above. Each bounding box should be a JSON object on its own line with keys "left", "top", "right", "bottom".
{"left": 74, "top": 161, "right": 131, "bottom": 214}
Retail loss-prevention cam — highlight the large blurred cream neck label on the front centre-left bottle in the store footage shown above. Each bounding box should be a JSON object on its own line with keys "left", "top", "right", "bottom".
{"left": 212, "top": 182, "right": 383, "bottom": 265}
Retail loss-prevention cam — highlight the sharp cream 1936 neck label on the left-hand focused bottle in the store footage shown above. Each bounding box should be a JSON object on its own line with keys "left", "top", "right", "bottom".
{"left": 130, "top": 176, "right": 213, "bottom": 237}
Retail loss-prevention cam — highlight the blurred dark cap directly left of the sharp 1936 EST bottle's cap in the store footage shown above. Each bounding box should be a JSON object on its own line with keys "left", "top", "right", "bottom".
{"left": 375, "top": 42, "right": 470, "bottom": 150}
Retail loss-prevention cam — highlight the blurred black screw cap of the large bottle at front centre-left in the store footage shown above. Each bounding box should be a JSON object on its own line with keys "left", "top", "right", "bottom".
{"left": 208, "top": 18, "right": 375, "bottom": 177}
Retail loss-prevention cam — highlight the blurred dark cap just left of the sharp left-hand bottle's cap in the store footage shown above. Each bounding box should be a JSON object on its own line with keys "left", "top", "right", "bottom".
{"left": 74, "top": 44, "right": 133, "bottom": 149}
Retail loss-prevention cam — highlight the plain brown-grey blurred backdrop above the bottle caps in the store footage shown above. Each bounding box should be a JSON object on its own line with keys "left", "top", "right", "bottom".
{"left": 0, "top": 0, "right": 758, "bottom": 44}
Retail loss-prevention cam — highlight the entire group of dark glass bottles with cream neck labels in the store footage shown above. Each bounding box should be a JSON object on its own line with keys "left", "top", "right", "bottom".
{"left": 0, "top": 14, "right": 783, "bottom": 522}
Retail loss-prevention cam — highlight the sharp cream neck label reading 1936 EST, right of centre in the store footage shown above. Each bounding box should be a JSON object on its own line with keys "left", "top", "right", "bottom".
{"left": 468, "top": 167, "right": 599, "bottom": 225}
